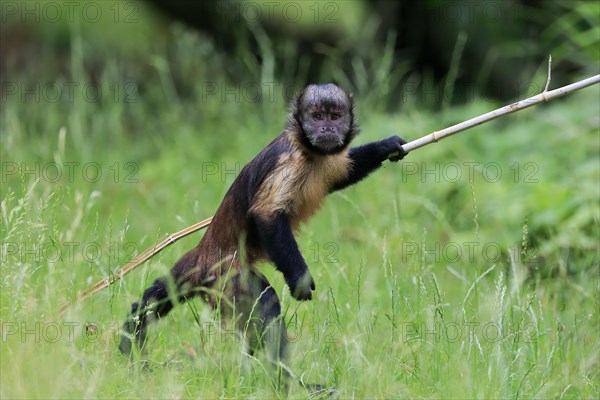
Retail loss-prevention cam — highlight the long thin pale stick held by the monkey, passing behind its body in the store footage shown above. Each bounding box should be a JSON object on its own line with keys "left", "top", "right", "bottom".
{"left": 61, "top": 72, "right": 600, "bottom": 313}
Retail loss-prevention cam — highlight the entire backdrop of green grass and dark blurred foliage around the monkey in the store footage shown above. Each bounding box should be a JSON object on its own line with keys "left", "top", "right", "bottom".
{"left": 0, "top": 0, "right": 600, "bottom": 398}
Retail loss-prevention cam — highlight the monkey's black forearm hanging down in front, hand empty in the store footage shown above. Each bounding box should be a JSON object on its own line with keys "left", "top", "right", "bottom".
{"left": 253, "top": 213, "right": 315, "bottom": 300}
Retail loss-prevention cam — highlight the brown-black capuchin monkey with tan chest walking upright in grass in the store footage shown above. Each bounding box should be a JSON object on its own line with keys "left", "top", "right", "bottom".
{"left": 119, "top": 84, "right": 406, "bottom": 392}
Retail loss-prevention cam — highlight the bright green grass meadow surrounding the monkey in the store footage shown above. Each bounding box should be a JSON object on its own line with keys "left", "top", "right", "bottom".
{"left": 0, "top": 7, "right": 600, "bottom": 399}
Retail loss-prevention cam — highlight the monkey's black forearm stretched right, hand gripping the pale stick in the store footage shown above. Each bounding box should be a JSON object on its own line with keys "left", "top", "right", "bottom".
{"left": 331, "top": 136, "right": 406, "bottom": 192}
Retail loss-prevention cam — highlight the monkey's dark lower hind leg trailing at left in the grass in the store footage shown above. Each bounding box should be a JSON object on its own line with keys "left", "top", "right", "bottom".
{"left": 119, "top": 277, "right": 181, "bottom": 355}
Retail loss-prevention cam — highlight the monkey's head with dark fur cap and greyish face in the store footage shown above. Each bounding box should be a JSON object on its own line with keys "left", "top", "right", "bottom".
{"left": 288, "top": 83, "right": 358, "bottom": 154}
